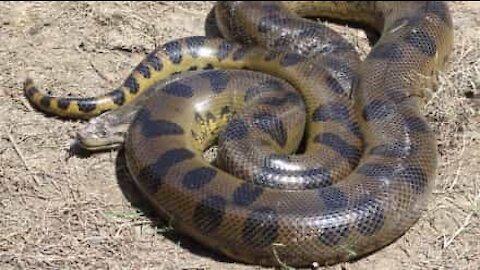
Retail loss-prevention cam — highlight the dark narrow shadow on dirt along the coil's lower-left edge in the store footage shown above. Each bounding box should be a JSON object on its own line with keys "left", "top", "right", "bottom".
{"left": 115, "top": 148, "right": 240, "bottom": 263}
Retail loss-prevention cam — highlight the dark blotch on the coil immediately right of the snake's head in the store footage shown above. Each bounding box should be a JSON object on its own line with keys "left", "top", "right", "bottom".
{"left": 138, "top": 109, "right": 185, "bottom": 138}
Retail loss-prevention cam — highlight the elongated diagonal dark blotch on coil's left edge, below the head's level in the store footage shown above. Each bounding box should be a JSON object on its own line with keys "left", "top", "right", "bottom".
{"left": 138, "top": 148, "right": 194, "bottom": 194}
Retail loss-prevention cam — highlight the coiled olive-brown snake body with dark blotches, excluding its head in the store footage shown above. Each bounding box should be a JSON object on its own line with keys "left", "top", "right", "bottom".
{"left": 25, "top": 1, "right": 453, "bottom": 266}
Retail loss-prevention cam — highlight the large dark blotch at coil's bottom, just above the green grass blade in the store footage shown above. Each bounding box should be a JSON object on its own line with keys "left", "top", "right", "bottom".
{"left": 242, "top": 207, "right": 279, "bottom": 248}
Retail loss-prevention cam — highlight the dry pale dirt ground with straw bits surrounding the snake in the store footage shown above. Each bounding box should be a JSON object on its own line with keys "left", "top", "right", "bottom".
{"left": 0, "top": 2, "right": 480, "bottom": 270}
